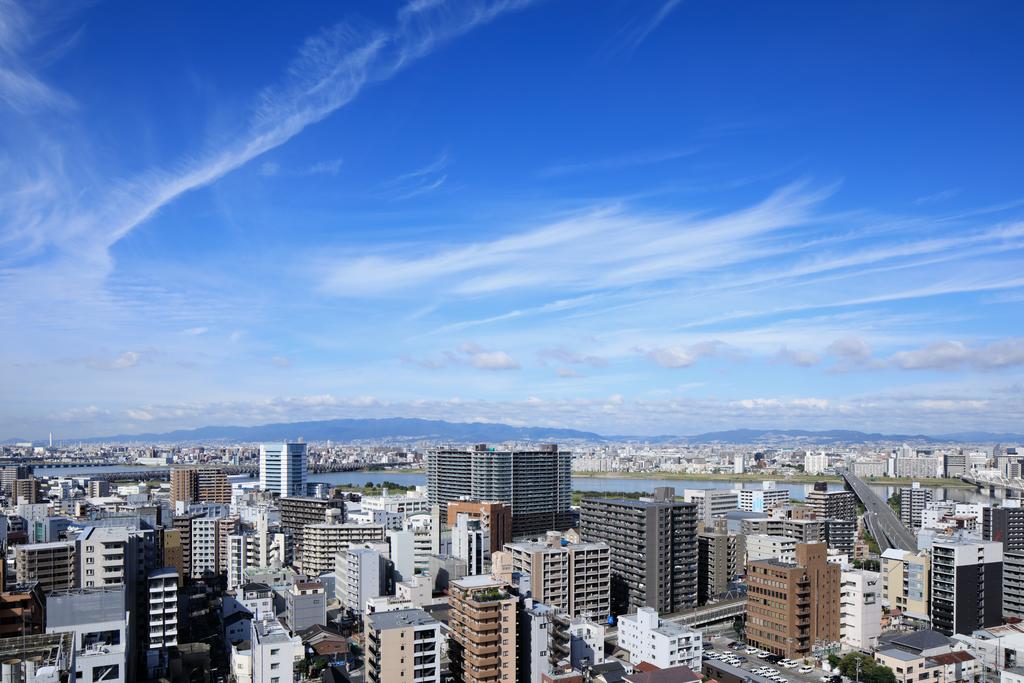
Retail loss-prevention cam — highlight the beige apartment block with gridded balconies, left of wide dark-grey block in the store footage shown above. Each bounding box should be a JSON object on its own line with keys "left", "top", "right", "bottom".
{"left": 504, "top": 542, "right": 611, "bottom": 620}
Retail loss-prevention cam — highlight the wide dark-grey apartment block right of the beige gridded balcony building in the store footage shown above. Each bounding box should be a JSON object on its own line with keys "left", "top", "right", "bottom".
{"left": 580, "top": 487, "right": 697, "bottom": 614}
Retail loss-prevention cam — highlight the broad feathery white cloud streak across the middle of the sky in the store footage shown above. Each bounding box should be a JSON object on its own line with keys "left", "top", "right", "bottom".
{"left": 321, "top": 183, "right": 833, "bottom": 296}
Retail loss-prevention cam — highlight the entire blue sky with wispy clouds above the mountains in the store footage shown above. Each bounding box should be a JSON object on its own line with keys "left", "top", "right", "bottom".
{"left": 0, "top": 0, "right": 1024, "bottom": 437}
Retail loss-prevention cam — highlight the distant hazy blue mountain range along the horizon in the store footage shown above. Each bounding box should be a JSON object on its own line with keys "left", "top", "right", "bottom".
{"left": 5, "top": 418, "right": 1024, "bottom": 444}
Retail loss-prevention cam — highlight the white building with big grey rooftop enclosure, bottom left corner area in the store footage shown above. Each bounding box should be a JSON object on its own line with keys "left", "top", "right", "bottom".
{"left": 45, "top": 589, "right": 129, "bottom": 683}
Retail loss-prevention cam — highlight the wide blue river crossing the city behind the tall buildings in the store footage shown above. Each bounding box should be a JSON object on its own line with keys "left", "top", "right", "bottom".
{"left": 36, "top": 465, "right": 992, "bottom": 503}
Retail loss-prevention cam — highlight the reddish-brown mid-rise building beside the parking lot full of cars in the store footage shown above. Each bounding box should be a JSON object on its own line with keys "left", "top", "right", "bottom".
{"left": 746, "top": 543, "right": 841, "bottom": 659}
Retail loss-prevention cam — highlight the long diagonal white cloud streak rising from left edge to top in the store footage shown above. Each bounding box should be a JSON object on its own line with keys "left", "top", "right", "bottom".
{"left": 0, "top": 0, "right": 530, "bottom": 288}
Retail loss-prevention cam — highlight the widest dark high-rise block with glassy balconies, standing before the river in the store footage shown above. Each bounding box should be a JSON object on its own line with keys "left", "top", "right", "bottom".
{"left": 427, "top": 444, "right": 572, "bottom": 538}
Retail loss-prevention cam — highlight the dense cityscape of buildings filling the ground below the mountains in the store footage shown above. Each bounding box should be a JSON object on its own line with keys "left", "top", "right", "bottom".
{"left": 0, "top": 440, "right": 1024, "bottom": 683}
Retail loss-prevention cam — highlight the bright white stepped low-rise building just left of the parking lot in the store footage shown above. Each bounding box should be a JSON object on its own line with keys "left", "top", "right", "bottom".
{"left": 618, "top": 607, "right": 703, "bottom": 671}
